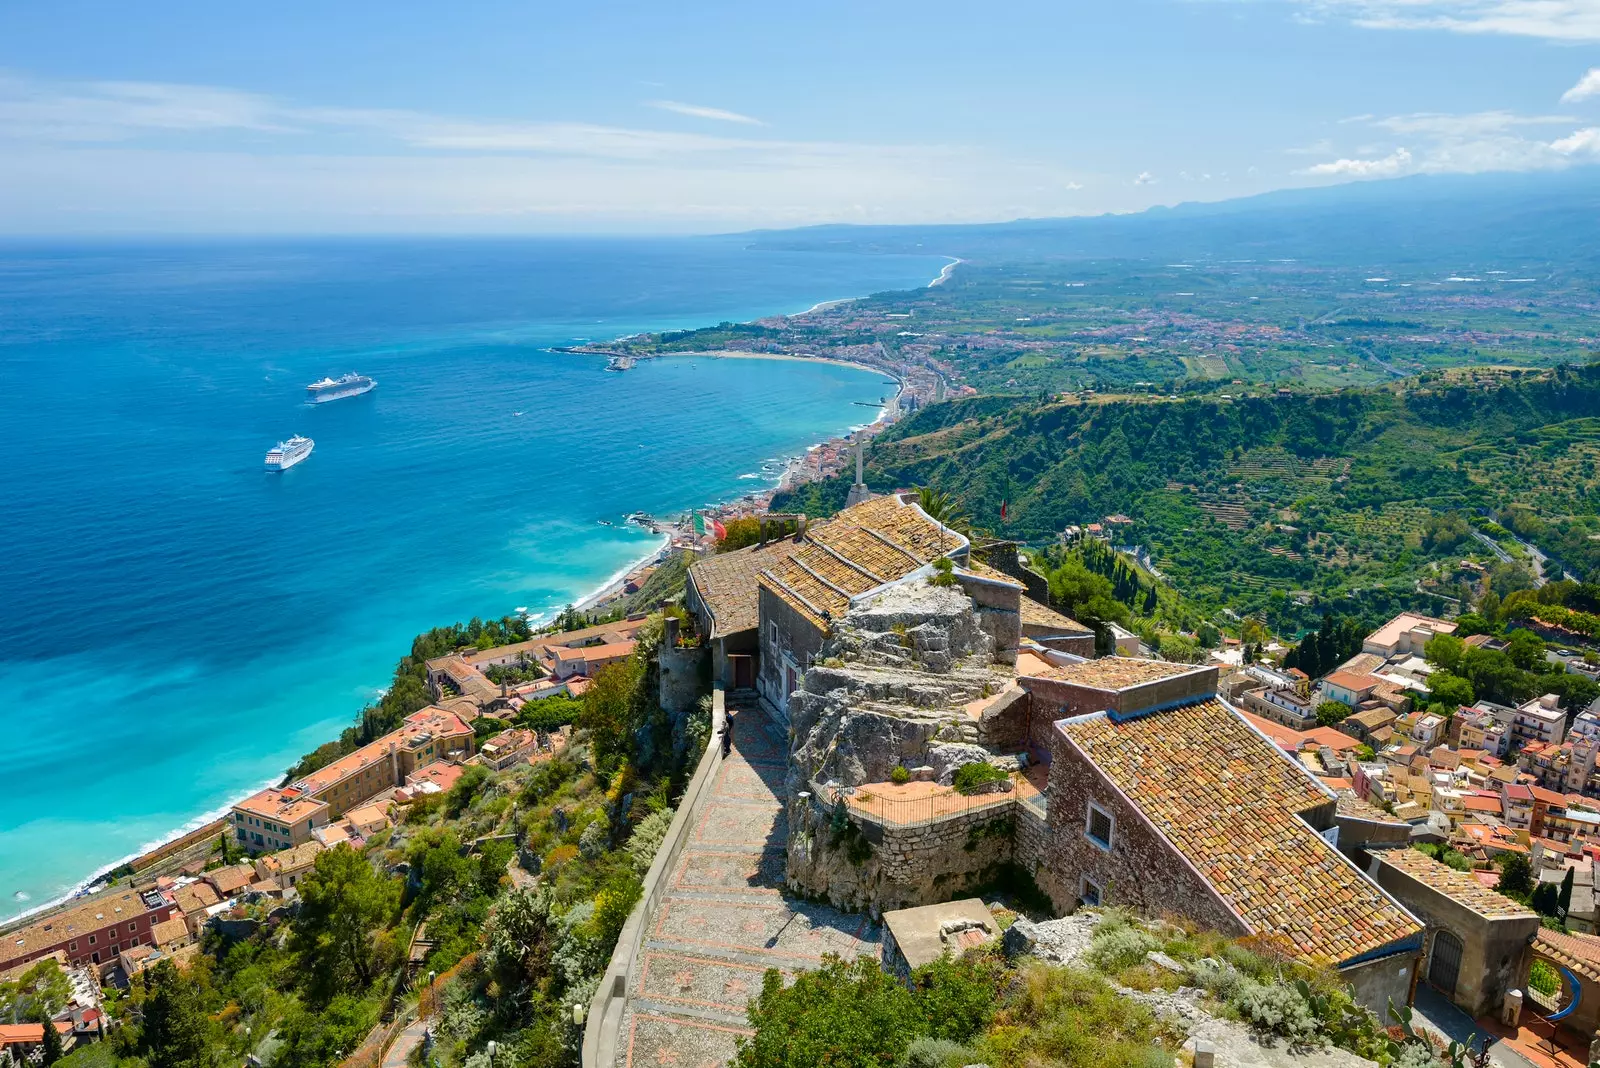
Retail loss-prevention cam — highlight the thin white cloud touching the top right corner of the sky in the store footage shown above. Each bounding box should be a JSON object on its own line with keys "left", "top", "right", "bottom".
{"left": 1267, "top": 0, "right": 1600, "bottom": 42}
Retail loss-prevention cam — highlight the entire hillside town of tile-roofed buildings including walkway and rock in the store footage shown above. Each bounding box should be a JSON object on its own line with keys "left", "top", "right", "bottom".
{"left": 0, "top": 460, "right": 1600, "bottom": 1068}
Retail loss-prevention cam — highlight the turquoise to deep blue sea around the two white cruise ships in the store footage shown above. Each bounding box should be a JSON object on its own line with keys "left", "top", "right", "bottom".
{"left": 0, "top": 238, "right": 942, "bottom": 916}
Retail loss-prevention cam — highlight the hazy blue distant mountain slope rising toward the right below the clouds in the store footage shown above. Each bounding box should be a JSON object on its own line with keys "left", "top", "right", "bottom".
{"left": 750, "top": 166, "right": 1600, "bottom": 270}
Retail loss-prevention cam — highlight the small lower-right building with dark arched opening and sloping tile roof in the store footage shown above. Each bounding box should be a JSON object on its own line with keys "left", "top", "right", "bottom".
{"left": 1371, "top": 847, "right": 1539, "bottom": 1017}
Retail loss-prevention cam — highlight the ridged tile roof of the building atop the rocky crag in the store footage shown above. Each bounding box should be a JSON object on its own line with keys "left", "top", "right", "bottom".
{"left": 757, "top": 494, "right": 966, "bottom": 630}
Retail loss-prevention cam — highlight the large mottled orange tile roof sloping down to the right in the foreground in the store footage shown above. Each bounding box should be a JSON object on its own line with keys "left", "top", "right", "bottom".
{"left": 1059, "top": 699, "right": 1421, "bottom": 964}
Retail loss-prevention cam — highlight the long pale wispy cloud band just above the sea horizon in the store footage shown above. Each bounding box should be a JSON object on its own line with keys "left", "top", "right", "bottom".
{"left": 0, "top": 75, "right": 1113, "bottom": 232}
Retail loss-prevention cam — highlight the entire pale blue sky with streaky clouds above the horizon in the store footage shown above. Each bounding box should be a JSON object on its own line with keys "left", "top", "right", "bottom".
{"left": 0, "top": 0, "right": 1600, "bottom": 233}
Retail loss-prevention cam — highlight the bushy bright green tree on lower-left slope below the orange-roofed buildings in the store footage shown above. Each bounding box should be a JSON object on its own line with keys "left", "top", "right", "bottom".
{"left": 294, "top": 843, "right": 400, "bottom": 996}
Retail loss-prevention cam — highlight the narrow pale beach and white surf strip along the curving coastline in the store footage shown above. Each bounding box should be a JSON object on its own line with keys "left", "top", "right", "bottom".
{"left": 0, "top": 261, "right": 940, "bottom": 931}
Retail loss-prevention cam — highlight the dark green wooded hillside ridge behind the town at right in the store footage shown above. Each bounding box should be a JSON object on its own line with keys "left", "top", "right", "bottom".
{"left": 773, "top": 363, "right": 1600, "bottom": 628}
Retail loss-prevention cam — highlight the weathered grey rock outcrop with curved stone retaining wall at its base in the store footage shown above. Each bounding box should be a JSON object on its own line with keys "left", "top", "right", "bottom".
{"left": 787, "top": 582, "right": 1011, "bottom": 908}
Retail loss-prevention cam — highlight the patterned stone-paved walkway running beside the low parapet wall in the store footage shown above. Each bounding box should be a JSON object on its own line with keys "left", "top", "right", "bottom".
{"left": 618, "top": 700, "right": 878, "bottom": 1068}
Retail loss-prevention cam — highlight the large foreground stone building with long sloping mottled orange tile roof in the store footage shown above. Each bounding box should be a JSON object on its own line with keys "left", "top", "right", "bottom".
{"left": 1026, "top": 681, "right": 1422, "bottom": 1010}
